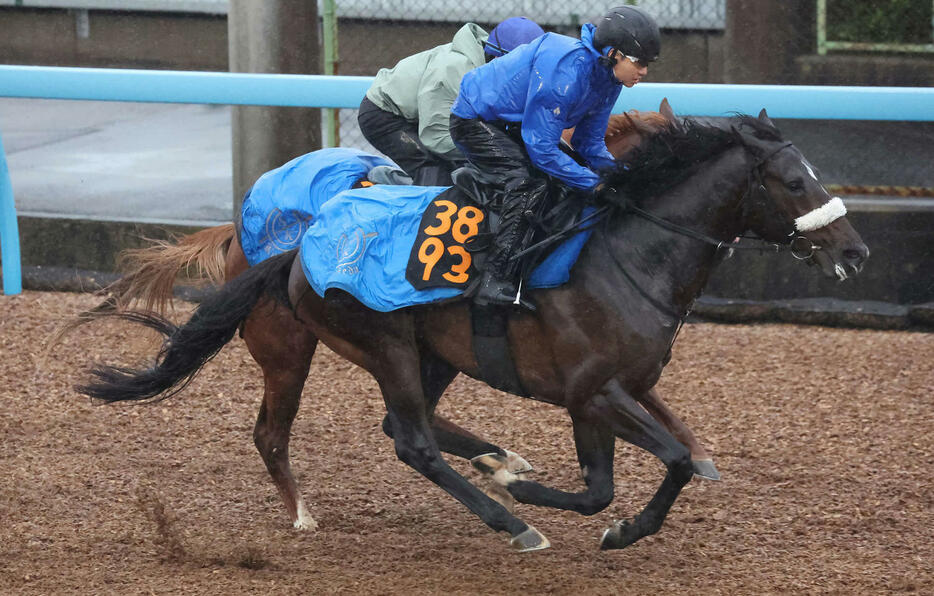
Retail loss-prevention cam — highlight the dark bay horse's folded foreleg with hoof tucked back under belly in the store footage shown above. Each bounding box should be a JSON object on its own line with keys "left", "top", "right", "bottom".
{"left": 474, "top": 414, "right": 616, "bottom": 515}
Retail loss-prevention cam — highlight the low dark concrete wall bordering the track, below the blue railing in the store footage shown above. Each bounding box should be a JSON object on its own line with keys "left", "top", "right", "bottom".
{"left": 20, "top": 208, "right": 934, "bottom": 329}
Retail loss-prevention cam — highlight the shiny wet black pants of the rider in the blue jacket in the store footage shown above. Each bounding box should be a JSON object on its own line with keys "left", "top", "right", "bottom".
{"left": 451, "top": 114, "right": 548, "bottom": 279}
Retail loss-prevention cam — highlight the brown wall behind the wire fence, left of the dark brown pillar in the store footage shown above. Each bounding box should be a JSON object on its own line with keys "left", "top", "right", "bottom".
{"left": 0, "top": 8, "right": 723, "bottom": 83}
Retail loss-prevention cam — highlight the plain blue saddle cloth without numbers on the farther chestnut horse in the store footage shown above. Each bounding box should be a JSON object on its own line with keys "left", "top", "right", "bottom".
{"left": 240, "top": 147, "right": 398, "bottom": 266}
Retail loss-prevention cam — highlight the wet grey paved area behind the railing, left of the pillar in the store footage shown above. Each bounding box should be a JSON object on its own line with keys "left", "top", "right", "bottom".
{"left": 0, "top": 99, "right": 233, "bottom": 225}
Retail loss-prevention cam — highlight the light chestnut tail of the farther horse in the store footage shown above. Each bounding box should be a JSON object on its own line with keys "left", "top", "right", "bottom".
{"left": 46, "top": 223, "right": 234, "bottom": 350}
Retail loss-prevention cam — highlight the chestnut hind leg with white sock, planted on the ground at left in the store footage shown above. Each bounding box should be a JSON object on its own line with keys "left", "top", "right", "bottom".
{"left": 243, "top": 302, "right": 318, "bottom": 530}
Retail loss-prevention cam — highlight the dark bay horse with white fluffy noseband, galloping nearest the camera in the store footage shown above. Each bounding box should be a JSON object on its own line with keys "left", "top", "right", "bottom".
{"left": 78, "top": 111, "right": 869, "bottom": 551}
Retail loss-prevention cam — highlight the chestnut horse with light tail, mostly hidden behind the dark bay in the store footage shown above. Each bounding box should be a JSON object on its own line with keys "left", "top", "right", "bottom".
{"left": 66, "top": 101, "right": 719, "bottom": 529}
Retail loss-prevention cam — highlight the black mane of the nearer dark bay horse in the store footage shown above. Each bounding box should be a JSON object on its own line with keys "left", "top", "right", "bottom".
{"left": 605, "top": 114, "right": 782, "bottom": 204}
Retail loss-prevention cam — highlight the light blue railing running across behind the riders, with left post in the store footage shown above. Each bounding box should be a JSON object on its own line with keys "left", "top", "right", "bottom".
{"left": 0, "top": 65, "right": 934, "bottom": 294}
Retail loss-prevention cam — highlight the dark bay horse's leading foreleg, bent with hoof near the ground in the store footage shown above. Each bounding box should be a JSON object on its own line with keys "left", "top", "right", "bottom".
{"left": 587, "top": 379, "right": 693, "bottom": 549}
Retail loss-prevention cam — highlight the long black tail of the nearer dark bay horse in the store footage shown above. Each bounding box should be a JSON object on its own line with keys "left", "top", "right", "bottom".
{"left": 76, "top": 249, "right": 298, "bottom": 402}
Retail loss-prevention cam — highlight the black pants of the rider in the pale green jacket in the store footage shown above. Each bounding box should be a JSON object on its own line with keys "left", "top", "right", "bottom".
{"left": 357, "top": 97, "right": 456, "bottom": 186}
